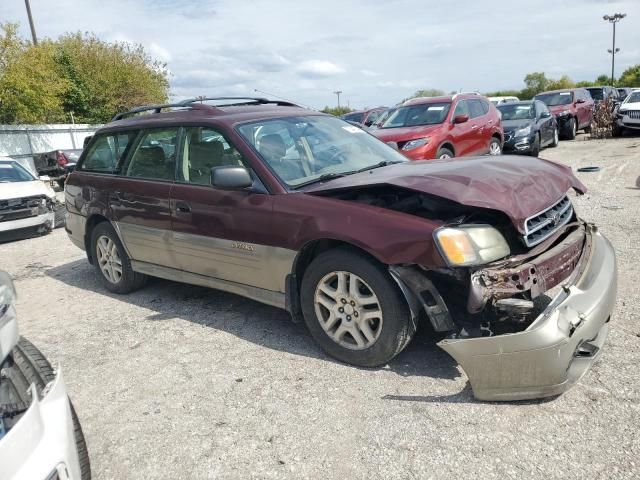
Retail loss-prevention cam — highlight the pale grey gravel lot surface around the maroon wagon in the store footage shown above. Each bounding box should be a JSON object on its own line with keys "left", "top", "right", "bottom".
{"left": 0, "top": 135, "right": 640, "bottom": 479}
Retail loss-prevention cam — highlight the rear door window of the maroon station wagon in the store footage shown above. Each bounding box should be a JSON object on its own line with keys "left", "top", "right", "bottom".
{"left": 125, "top": 127, "right": 178, "bottom": 181}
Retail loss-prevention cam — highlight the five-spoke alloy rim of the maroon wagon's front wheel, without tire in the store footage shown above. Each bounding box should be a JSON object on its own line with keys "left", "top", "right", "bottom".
{"left": 314, "top": 271, "right": 382, "bottom": 350}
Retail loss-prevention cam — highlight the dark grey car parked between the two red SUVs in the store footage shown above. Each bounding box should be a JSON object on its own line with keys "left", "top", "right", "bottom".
{"left": 497, "top": 100, "right": 559, "bottom": 157}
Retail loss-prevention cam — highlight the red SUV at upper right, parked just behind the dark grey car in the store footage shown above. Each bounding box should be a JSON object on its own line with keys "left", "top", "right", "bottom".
{"left": 533, "top": 88, "right": 594, "bottom": 140}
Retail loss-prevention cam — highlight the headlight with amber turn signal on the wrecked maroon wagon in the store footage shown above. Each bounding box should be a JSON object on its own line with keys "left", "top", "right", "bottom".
{"left": 433, "top": 225, "right": 510, "bottom": 267}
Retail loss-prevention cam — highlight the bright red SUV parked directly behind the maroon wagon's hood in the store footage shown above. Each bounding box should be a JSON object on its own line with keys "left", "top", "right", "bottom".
{"left": 371, "top": 93, "right": 504, "bottom": 160}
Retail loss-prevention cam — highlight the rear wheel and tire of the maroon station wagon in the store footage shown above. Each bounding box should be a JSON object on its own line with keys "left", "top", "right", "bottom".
{"left": 91, "top": 222, "right": 147, "bottom": 293}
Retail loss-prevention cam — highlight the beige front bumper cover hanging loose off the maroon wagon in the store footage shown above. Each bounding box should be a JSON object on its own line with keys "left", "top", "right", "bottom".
{"left": 438, "top": 227, "right": 617, "bottom": 401}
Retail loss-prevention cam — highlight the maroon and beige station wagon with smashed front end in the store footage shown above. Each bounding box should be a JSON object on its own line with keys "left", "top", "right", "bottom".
{"left": 65, "top": 98, "right": 616, "bottom": 400}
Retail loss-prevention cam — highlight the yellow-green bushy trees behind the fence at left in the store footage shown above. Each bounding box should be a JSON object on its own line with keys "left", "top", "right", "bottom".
{"left": 0, "top": 24, "right": 169, "bottom": 123}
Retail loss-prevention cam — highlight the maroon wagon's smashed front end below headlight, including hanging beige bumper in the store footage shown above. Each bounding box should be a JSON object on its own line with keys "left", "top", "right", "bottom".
{"left": 392, "top": 218, "right": 617, "bottom": 401}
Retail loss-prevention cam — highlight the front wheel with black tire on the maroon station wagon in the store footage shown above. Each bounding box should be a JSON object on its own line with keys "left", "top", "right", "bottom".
{"left": 300, "top": 248, "right": 415, "bottom": 367}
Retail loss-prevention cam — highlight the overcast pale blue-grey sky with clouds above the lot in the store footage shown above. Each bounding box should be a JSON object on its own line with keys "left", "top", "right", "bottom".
{"left": 0, "top": 0, "right": 640, "bottom": 108}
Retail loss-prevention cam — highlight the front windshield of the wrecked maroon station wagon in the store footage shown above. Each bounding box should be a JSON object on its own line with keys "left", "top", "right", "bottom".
{"left": 238, "top": 115, "right": 407, "bottom": 187}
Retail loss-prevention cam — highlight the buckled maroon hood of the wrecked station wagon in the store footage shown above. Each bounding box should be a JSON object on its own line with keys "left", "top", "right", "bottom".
{"left": 303, "top": 155, "right": 587, "bottom": 233}
